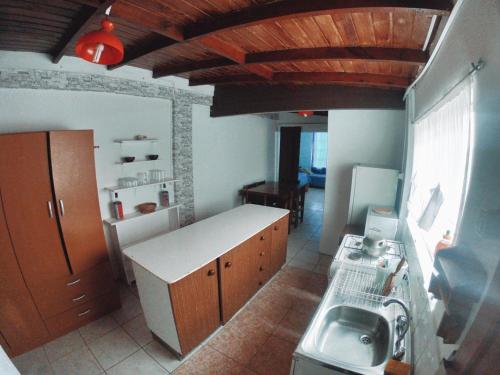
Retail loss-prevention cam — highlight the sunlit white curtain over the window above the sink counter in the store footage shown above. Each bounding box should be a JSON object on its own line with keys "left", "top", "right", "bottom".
{"left": 408, "top": 82, "right": 471, "bottom": 254}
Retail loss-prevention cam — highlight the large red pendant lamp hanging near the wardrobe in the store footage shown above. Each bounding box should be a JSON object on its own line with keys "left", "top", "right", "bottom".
{"left": 75, "top": 7, "right": 123, "bottom": 65}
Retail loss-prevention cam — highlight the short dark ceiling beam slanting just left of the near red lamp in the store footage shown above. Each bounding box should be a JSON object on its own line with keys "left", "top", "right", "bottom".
{"left": 52, "top": 0, "right": 116, "bottom": 64}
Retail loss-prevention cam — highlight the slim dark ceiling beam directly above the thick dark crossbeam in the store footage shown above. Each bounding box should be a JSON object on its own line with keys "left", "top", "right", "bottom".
{"left": 189, "top": 72, "right": 411, "bottom": 89}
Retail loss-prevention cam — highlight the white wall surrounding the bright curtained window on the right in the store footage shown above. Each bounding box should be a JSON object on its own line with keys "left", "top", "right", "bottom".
{"left": 405, "top": 0, "right": 500, "bottom": 374}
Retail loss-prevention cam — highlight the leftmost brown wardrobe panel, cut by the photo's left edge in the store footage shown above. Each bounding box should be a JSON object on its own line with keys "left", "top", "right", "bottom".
{"left": 0, "top": 201, "right": 48, "bottom": 356}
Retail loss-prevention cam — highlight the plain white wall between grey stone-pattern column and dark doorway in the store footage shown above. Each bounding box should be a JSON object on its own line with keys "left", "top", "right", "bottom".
{"left": 193, "top": 105, "right": 275, "bottom": 220}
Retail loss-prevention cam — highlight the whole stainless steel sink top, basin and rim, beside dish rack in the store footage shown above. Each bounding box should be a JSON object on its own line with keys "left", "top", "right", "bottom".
{"left": 294, "top": 264, "right": 410, "bottom": 375}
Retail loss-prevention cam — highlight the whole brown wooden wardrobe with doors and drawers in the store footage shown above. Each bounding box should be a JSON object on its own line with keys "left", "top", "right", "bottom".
{"left": 0, "top": 130, "right": 120, "bottom": 356}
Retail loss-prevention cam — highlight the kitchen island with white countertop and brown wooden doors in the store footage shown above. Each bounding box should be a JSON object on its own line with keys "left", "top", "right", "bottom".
{"left": 124, "top": 204, "right": 289, "bottom": 356}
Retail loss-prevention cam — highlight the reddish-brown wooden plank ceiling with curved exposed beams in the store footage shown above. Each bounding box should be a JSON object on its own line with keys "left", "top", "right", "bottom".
{"left": 0, "top": 0, "right": 453, "bottom": 100}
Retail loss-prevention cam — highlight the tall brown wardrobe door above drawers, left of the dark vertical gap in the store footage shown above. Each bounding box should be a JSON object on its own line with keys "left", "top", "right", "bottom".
{"left": 0, "top": 132, "right": 70, "bottom": 287}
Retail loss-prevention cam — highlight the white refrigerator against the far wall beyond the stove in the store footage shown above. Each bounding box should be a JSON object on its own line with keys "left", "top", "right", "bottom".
{"left": 347, "top": 164, "right": 399, "bottom": 225}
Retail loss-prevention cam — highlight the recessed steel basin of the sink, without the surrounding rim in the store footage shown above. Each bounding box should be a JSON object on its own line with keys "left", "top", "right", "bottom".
{"left": 312, "top": 306, "right": 392, "bottom": 367}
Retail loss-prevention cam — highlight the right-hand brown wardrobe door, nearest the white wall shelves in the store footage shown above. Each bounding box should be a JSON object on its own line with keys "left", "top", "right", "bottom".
{"left": 49, "top": 130, "right": 107, "bottom": 273}
